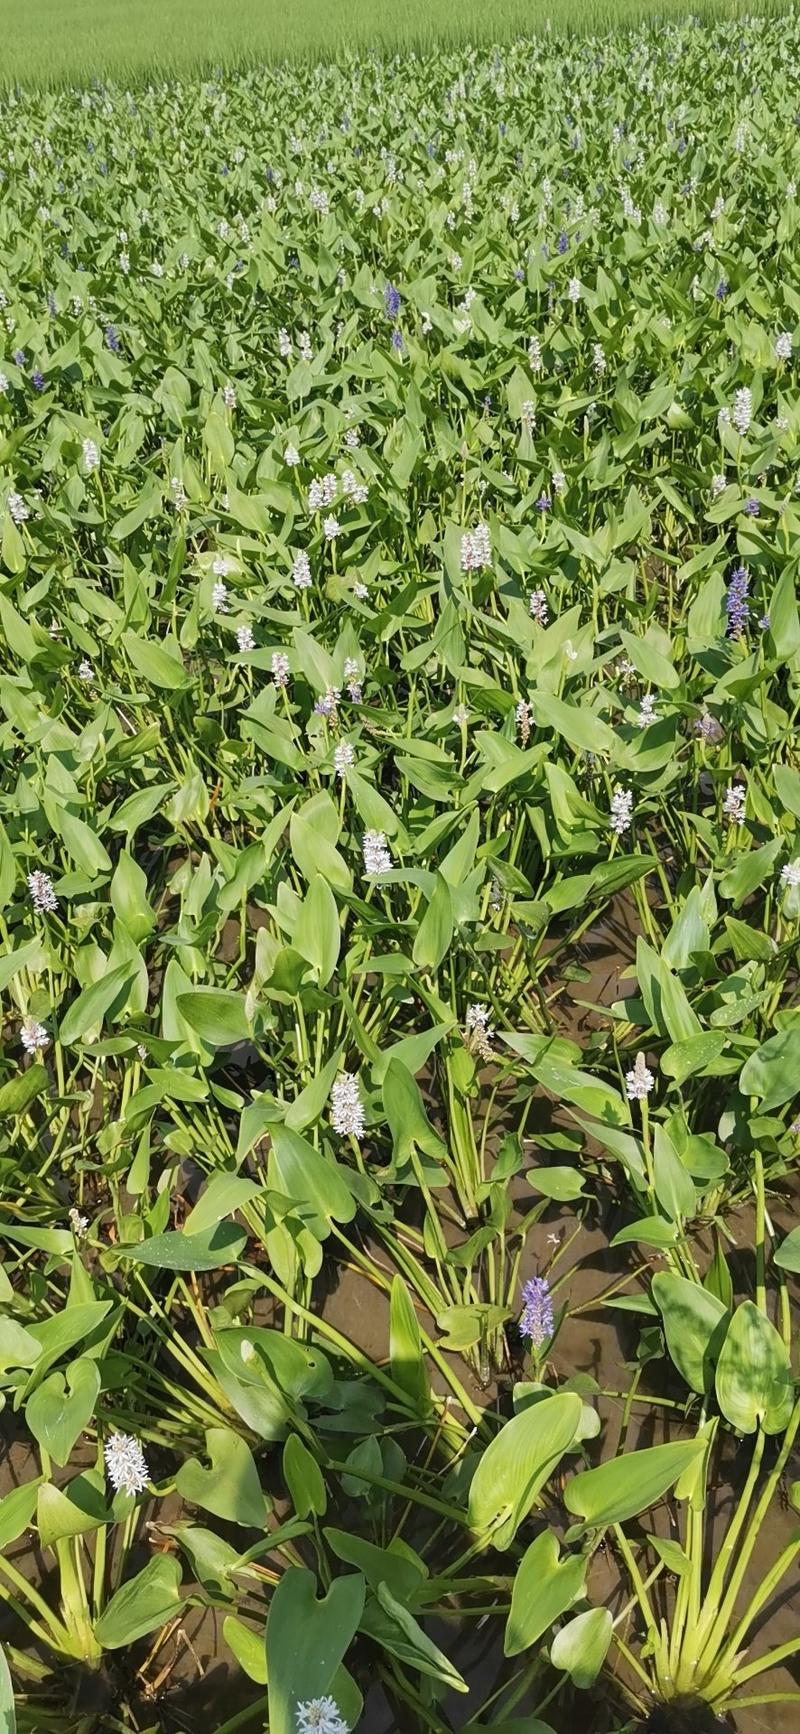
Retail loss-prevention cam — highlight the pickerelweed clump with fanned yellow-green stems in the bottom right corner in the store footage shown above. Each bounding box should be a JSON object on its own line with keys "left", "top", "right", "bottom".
{"left": 576, "top": 1164, "right": 800, "bottom": 1713}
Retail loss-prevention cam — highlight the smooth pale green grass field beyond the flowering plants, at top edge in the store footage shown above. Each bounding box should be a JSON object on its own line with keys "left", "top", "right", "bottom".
{"left": 0, "top": 0, "right": 784, "bottom": 87}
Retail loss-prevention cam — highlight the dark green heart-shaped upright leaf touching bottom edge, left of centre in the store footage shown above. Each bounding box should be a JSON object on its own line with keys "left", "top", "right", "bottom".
{"left": 266, "top": 1566, "right": 364, "bottom": 1734}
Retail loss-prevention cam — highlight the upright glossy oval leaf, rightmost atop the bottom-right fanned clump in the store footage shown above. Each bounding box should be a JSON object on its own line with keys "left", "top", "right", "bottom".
{"left": 715, "top": 1301, "right": 795, "bottom": 1432}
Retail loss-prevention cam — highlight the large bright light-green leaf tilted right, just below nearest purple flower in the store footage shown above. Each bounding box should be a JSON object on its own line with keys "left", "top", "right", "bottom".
{"left": 469, "top": 1392, "right": 581, "bottom": 1548}
